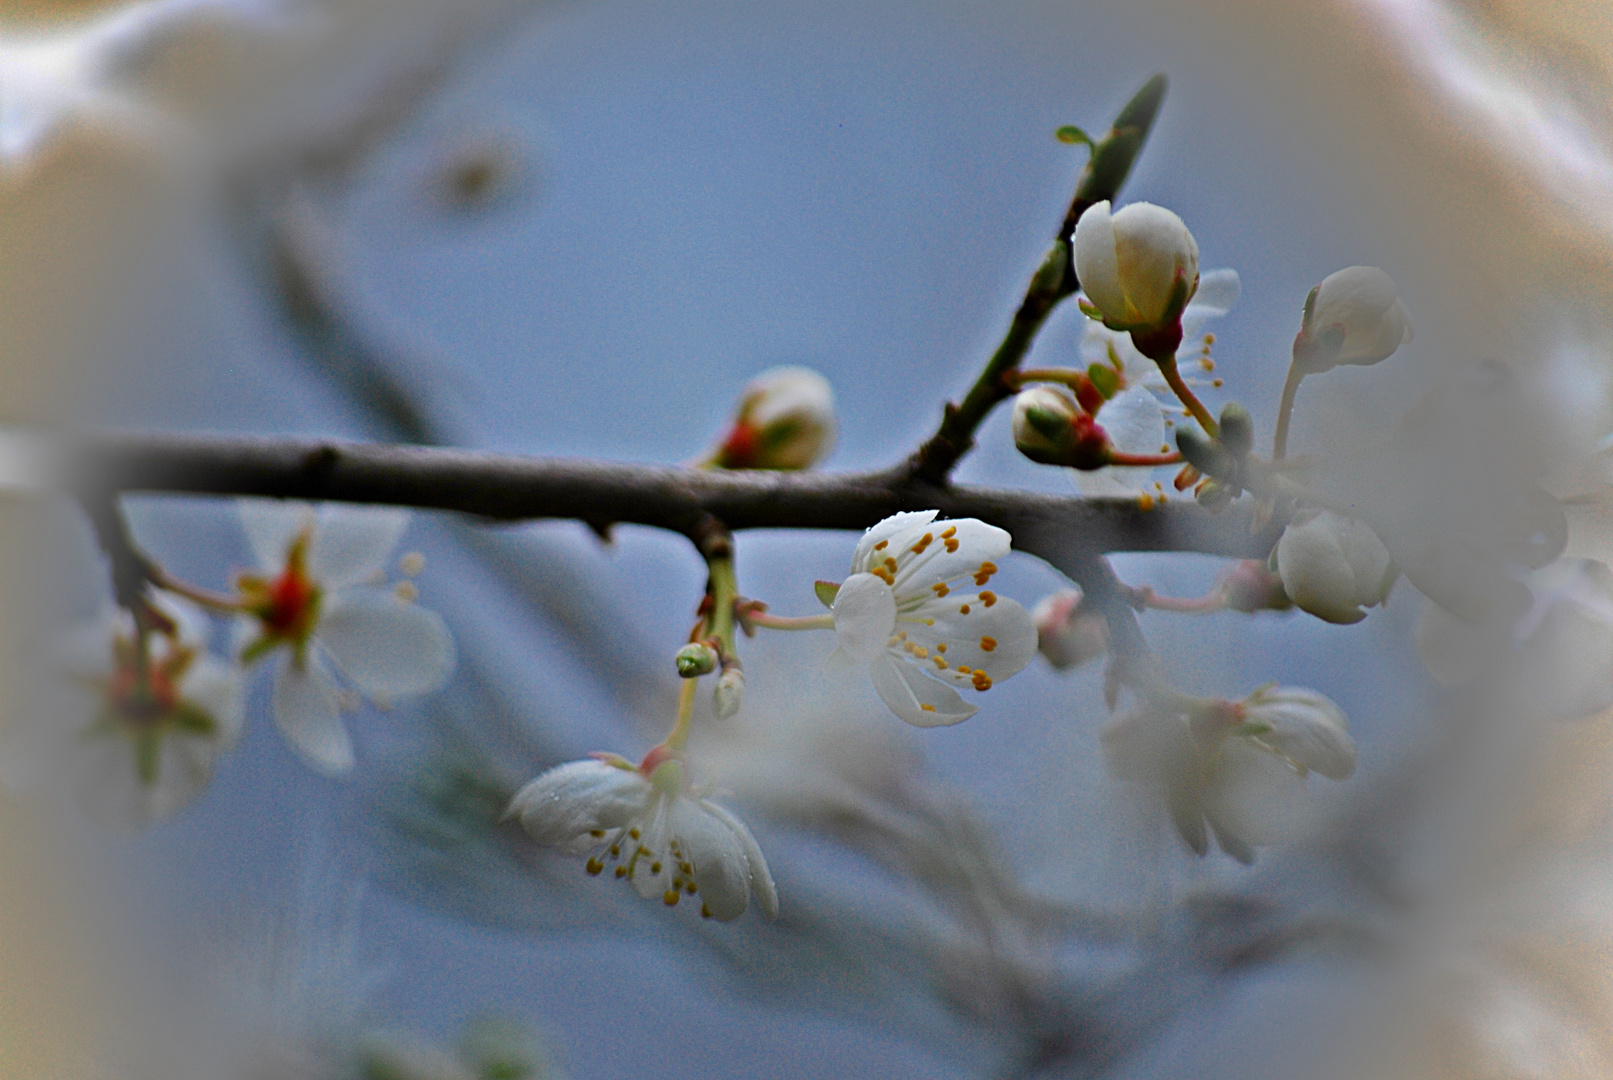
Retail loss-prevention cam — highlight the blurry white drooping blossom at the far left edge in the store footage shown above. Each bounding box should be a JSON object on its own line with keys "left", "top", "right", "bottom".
{"left": 3, "top": 596, "right": 244, "bottom": 829}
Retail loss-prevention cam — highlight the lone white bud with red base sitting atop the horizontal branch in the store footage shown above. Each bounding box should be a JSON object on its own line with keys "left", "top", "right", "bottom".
{"left": 711, "top": 368, "right": 834, "bottom": 469}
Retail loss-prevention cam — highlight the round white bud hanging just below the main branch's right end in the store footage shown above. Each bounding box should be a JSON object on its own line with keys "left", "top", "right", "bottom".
{"left": 1277, "top": 509, "right": 1395, "bottom": 622}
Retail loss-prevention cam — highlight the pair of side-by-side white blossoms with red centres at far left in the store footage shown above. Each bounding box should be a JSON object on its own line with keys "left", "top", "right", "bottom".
{"left": 5, "top": 500, "right": 455, "bottom": 825}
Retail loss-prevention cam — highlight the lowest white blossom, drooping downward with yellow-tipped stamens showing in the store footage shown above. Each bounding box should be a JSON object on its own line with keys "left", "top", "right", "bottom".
{"left": 506, "top": 753, "right": 779, "bottom": 922}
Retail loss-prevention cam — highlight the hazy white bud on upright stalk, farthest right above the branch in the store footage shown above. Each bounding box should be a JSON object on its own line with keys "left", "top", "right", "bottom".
{"left": 1294, "top": 266, "right": 1411, "bottom": 374}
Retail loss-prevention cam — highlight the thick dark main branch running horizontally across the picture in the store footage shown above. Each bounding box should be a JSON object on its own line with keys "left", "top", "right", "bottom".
{"left": 69, "top": 434, "right": 1281, "bottom": 567}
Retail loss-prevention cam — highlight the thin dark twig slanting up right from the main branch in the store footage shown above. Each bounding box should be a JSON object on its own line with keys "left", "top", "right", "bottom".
{"left": 907, "top": 76, "right": 1165, "bottom": 484}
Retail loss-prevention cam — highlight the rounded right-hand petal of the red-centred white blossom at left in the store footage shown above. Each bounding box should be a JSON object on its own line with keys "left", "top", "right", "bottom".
{"left": 315, "top": 588, "right": 455, "bottom": 698}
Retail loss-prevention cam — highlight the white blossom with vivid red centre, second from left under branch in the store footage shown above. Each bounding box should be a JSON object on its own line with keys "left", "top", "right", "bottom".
{"left": 237, "top": 500, "right": 455, "bottom": 775}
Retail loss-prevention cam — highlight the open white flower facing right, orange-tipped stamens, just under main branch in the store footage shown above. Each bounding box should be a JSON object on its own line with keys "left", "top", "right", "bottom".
{"left": 831, "top": 509, "right": 1037, "bottom": 727}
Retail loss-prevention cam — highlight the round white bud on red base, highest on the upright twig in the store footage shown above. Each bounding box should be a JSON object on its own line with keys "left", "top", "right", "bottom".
{"left": 1073, "top": 200, "right": 1198, "bottom": 336}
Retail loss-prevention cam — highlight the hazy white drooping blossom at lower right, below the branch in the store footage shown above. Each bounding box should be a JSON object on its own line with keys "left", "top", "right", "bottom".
{"left": 1100, "top": 687, "right": 1355, "bottom": 862}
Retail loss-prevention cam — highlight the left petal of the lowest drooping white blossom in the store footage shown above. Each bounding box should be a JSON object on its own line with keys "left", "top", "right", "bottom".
{"left": 508, "top": 759, "right": 652, "bottom": 853}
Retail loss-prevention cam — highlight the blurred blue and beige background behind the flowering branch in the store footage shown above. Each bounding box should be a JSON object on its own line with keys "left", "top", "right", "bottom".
{"left": 9, "top": 0, "right": 1613, "bottom": 1078}
